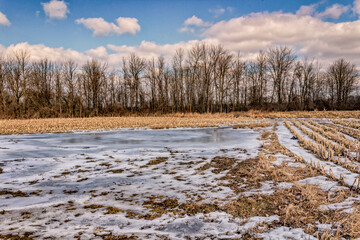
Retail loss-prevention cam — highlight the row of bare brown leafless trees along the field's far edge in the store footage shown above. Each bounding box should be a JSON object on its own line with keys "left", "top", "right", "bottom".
{"left": 0, "top": 44, "right": 360, "bottom": 118}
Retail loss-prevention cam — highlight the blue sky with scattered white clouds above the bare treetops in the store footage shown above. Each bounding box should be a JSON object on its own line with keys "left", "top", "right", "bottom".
{"left": 0, "top": 0, "right": 360, "bottom": 67}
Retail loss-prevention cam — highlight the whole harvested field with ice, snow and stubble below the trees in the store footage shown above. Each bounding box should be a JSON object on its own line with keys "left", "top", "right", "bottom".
{"left": 0, "top": 112, "right": 360, "bottom": 239}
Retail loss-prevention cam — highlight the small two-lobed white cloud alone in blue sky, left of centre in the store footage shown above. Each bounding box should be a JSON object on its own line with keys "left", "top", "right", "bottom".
{"left": 75, "top": 17, "right": 141, "bottom": 36}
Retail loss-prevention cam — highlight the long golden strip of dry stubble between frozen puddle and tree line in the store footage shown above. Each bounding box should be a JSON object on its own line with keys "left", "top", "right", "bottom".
{"left": 0, "top": 111, "right": 360, "bottom": 134}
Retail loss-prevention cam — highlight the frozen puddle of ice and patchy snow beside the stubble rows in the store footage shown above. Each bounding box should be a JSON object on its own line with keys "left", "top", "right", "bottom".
{"left": 0, "top": 128, "right": 272, "bottom": 239}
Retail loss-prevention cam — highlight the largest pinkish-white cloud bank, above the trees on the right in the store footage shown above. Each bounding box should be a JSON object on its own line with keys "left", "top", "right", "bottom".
{"left": 202, "top": 12, "right": 360, "bottom": 64}
